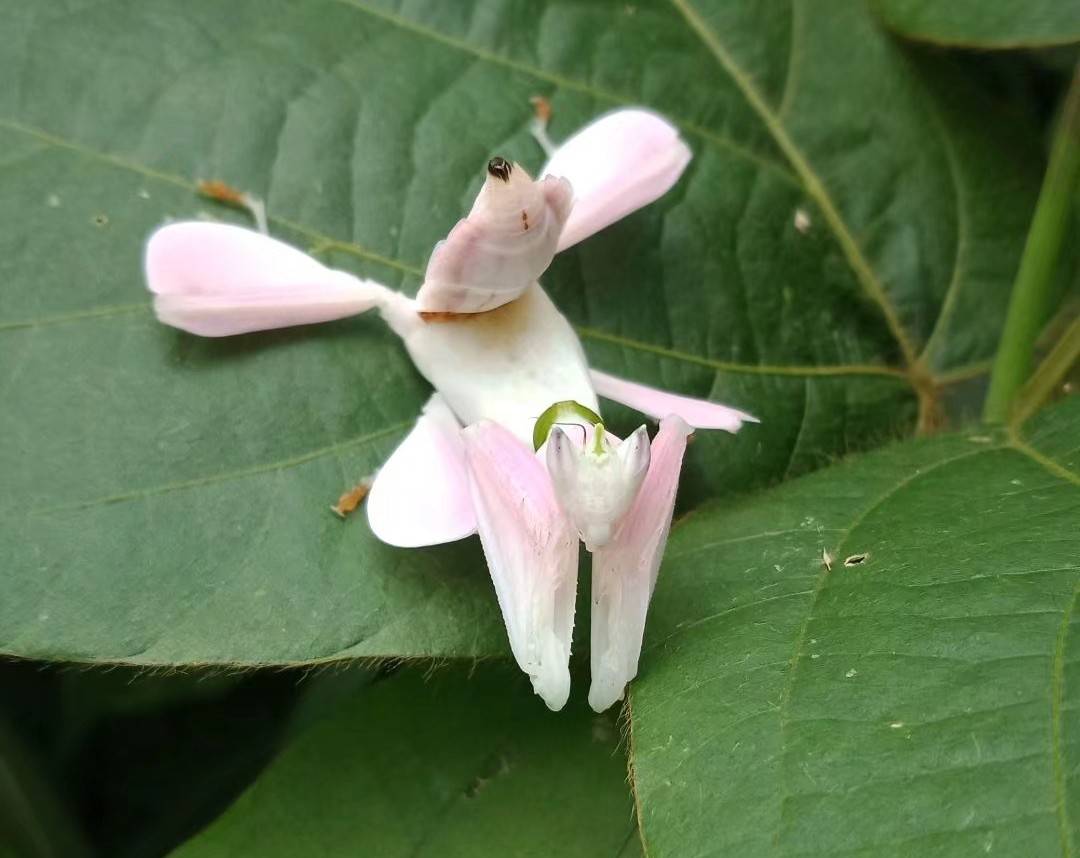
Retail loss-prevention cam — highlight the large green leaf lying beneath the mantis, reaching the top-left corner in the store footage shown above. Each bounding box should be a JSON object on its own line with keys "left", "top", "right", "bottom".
{"left": 0, "top": 0, "right": 1038, "bottom": 665}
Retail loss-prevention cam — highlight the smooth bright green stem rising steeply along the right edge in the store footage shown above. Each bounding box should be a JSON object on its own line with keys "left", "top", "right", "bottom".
{"left": 983, "top": 64, "right": 1080, "bottom": 423}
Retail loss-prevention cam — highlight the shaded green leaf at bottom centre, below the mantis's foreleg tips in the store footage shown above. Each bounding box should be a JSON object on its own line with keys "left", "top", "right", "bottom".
{"left": 174, "top": 667, "right": 639, "bottom": 858}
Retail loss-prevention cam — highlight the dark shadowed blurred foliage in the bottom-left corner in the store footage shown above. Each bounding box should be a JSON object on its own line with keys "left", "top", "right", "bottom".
{"left": 0, "top": 662, "right": 378, "bottom": 858}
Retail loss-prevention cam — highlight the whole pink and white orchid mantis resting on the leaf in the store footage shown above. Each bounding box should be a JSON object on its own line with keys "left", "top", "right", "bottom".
{"left": 146, "top": 109, "right": 756, "bottom": 711}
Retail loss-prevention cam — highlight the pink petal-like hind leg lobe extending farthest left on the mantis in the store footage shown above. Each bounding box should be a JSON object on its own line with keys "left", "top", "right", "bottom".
{"left": 145, "top": 222, "right": 393, "bottom": 337}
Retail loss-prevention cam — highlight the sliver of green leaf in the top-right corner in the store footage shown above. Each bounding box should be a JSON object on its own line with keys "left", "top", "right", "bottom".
{"left": 869, "top": 0, "right": 1080, "bottom": 49}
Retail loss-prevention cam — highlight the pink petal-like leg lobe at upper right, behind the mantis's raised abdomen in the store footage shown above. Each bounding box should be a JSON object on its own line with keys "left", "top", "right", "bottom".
{"left": 540, "top": 108, "right": 691, "bottom": 251}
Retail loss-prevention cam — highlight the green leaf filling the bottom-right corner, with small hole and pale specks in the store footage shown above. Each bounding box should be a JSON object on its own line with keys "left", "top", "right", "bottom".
{"left": 632, "top": 397, "right": 1080, "bottom": 857}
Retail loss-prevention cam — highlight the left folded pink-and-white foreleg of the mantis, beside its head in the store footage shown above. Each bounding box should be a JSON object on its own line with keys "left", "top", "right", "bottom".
{"left": 463, "top": 421, "right": 578, "bottom": 711}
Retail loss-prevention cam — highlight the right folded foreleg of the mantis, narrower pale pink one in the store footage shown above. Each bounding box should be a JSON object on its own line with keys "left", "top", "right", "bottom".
{"left": 589, "top": 415, "right": 691, "bottom": 712}
